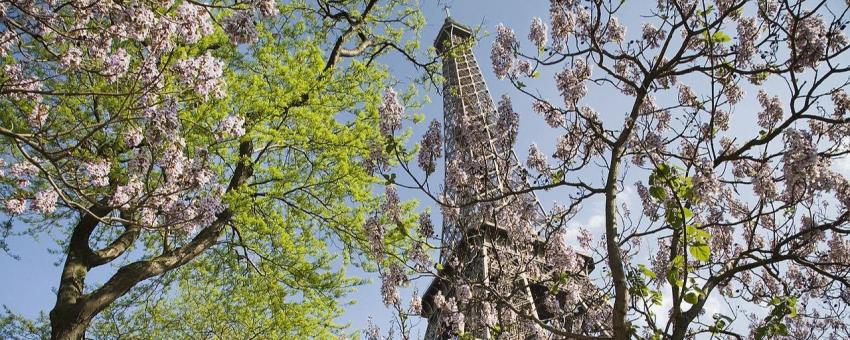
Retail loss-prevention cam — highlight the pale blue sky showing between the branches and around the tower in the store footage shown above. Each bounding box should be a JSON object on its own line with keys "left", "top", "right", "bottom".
{"left": 6, "top": 0, "right": 850, "bottom": 334}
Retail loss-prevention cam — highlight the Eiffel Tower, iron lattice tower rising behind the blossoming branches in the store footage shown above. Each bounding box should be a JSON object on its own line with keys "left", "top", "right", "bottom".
{"left": 422, "top": 16, "right": 593, "bottom": 339}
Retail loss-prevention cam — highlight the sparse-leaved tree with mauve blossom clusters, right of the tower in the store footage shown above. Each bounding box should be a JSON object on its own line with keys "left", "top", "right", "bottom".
{"left": 382, "top": 0, "right": 850, "bottom": 339}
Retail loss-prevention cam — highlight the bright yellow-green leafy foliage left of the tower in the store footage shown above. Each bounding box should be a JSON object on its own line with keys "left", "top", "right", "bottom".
{"left": 70, "top": 2, "right": 418, "bottom": 339}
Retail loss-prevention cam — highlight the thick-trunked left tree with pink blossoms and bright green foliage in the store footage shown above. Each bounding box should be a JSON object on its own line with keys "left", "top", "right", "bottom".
{"left": 0, "top": 0, "right": 422, "bottom": 339}
